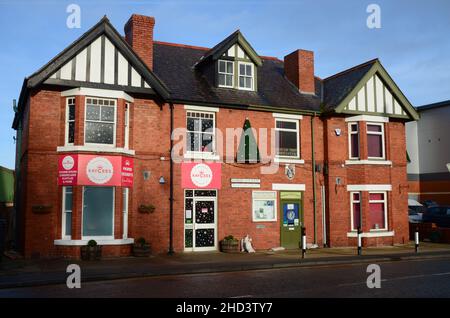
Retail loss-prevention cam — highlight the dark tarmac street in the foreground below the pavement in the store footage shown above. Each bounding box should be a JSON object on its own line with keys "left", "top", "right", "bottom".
{"left": 0, "top": 256, "right": 450, "bottom": 298}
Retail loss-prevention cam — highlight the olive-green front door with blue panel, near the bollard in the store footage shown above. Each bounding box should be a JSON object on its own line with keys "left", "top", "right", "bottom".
{"left": 280, "top": 192, "right": 303, "bottom": 249}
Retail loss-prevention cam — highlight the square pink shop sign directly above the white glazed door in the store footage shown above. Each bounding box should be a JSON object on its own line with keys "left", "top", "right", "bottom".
{"left": 181, "top": 162, "right": 222, "bottom": 189}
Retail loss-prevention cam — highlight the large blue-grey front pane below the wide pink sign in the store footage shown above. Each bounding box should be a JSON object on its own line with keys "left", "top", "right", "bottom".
{"left": 82, "top": 187, "right": 114, "bottom": 239}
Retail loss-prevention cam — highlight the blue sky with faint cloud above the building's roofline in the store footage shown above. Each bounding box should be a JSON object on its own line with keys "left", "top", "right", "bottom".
{"left": 0, "top": 0, "right": 450, "bottom": 168}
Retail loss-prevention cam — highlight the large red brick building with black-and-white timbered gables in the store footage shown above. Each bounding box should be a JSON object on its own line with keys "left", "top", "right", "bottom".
{"left": 13, "top": 15, "right": 417, "bottom": 257}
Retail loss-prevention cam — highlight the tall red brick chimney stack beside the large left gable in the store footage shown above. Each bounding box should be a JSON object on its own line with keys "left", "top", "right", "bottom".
{"left": 124, "top": 14, "right": 155, "bottom": 70}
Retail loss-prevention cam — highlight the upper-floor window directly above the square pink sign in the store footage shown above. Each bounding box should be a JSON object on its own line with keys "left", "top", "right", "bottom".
{"left": 186, "top": 112, "right": 215, "bottom": 153}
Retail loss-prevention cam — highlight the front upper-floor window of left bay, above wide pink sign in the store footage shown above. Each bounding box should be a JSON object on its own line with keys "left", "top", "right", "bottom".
{"left": 84, "top": 97, "right": 116, "bottom": 146}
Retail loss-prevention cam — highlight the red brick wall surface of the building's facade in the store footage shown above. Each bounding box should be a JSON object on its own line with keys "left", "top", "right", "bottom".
{"left": 21, "top": 85, "right": 408, "bottom": 257}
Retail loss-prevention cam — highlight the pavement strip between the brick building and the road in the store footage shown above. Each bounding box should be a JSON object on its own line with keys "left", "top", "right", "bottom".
{"left": 0, "top": 242, "right": 450, "bottom": 289}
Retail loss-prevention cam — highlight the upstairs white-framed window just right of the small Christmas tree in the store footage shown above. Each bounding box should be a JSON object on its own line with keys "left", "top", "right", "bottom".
{"left": 275, "top": 118, "right": 300, "bottom": 158}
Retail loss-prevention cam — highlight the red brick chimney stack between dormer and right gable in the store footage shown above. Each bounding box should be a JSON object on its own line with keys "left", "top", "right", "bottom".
{"left": 284, "top": 50, "right": 315, "bottom": 94}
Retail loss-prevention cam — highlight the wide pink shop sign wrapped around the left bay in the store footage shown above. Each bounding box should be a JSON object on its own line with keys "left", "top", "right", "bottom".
{"left": 58, "top": 154, "right": 134, "bottom": 187}
